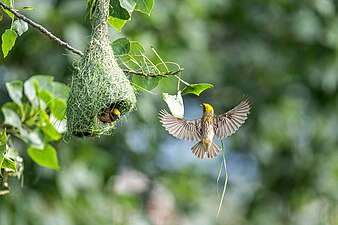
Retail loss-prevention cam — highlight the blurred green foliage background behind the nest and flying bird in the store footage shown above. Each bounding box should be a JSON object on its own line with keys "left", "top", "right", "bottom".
{"left": 0, "top": 0, "right": 338, "bottom": 225}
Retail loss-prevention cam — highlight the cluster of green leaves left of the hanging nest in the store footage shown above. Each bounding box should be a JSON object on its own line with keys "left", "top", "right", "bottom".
{"left": 0, "top": 75, "right": 69, "bottom": 193}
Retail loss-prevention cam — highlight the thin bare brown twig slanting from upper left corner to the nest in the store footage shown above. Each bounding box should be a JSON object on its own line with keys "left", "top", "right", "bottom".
{"left": 0, "top": 1, "right": 83, "bottom": 56}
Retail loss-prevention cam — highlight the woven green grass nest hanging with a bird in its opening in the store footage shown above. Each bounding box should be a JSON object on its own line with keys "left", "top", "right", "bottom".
{"left": 67, "top": 0, "right": 136, "bottom": 137}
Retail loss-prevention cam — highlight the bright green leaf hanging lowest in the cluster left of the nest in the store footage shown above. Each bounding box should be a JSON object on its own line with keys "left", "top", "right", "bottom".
{"left": 28, "top": 145, "right": 59, "bottom": 170}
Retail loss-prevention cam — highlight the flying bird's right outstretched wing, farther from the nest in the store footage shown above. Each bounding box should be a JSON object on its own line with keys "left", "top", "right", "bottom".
{"left": 214, "top": 98, "right": 251, "bottom": 139}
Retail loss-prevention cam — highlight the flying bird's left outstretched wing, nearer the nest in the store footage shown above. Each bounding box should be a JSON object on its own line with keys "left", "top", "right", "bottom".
{"left": 159, "top": 109, "right": 201, "bottom": 141}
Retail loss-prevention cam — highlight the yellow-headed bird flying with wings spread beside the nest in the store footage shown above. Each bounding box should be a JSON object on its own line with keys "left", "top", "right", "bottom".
{"left": 159, "top": 98, "right": 251, "bottom": 159}
